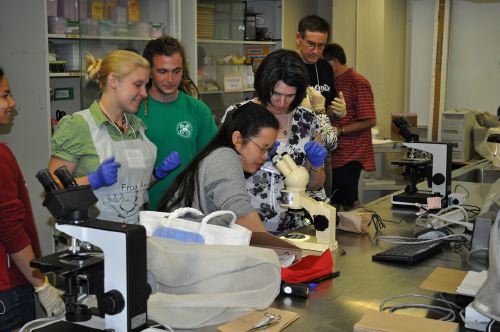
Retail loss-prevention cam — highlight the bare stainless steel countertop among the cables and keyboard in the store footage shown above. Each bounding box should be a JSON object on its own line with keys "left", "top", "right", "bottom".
{"left": 192, "top": 162, "right": 500, "bottom": 332}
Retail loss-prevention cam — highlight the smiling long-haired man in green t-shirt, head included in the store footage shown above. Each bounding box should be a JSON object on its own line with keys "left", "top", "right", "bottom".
{"left": 137, "top": 36, "right": 217, "bottom": 210}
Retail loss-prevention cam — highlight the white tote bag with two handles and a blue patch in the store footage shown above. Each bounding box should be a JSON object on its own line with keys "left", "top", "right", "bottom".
{"left": 139, "top": 208, "right": 252, "bottom": 245}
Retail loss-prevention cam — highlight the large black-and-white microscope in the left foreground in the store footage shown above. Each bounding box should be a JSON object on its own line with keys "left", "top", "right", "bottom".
{"left": 30, "top": 166, "right": 151, "bottom": 332}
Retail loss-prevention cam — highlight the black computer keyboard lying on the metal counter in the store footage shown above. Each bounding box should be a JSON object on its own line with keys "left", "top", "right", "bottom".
{"left": 372, "top": 241, "right": 445, "bottom": 265}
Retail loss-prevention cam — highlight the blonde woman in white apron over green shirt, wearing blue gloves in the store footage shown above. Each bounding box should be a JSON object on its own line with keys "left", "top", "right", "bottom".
{"left": 49, "top": 50, "right": 180, "bottom": 223}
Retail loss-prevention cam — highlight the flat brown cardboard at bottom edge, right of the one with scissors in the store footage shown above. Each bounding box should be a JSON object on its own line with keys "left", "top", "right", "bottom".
{"left": 353, "top": 310, "right": 458, "bottom": 332}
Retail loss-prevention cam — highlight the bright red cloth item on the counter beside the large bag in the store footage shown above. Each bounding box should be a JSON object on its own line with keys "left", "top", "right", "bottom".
{"left": 281, "top": 250, "right": 333, "bottom": 284}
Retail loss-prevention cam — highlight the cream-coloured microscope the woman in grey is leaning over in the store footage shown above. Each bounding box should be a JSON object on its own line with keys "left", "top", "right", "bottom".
{"left": 273, "top": 154, "right": 337, "bottom": 251}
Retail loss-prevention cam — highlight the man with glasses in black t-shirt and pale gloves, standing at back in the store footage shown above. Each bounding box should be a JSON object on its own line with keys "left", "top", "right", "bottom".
{"left": 296, "top": 15, "right": 346, "bottom": 198}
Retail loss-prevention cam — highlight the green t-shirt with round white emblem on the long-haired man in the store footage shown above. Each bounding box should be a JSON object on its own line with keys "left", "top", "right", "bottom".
{"left": 137, "top": 91, "right": 217, "bottom": 210}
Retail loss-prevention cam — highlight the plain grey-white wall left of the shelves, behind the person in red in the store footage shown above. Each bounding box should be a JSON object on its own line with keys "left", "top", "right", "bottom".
{"left": 0, "top": 0, "right": 53, "bottom": 254}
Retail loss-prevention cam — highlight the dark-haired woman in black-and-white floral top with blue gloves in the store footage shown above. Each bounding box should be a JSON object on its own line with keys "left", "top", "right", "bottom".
{"left": 222, "top": 49, "right": 327, "bottom": 232}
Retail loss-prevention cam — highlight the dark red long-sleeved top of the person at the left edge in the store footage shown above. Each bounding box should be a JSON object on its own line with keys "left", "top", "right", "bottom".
{"left": 0, "top": 144, "right": 40, "bottom": 291}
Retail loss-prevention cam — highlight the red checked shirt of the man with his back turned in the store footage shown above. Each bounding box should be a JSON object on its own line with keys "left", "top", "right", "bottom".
{"left": 332, "top": 68, "right": 377, "bottom": 171}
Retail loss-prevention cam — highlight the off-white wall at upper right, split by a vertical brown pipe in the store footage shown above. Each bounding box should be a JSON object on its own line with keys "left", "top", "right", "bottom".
{"left": 408, "top": 0, "right": 500, "bottom": 125}
